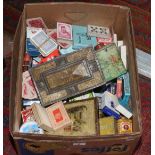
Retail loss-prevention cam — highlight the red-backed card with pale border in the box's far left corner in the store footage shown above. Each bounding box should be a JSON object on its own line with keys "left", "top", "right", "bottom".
{"left": 26, "top": 17, "right": 47, "bottom": 29}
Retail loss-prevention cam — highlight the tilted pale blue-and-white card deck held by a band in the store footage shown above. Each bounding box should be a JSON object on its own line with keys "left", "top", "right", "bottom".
{"left": 30, "top": 30, "right": 57, "bottom": 57}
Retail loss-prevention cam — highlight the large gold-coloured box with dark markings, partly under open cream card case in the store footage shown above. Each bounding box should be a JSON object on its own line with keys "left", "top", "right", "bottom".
{"left": 47, "top": 98, "right": 99, "bottom": 136}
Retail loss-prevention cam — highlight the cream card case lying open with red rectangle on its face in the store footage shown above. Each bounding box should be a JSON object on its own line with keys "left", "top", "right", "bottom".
{"left": 31, "top": 102, "right": 72, "bottom": 131}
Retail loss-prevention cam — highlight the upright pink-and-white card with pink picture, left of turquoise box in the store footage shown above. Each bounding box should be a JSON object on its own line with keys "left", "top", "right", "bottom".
{"left": 57, "top": 22, "right": 72, "bottom": 40}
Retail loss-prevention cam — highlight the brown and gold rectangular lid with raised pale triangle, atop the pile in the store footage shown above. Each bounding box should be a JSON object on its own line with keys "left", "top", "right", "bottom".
{"left": 29, "top": 48, "right": 105, "bottom": 106}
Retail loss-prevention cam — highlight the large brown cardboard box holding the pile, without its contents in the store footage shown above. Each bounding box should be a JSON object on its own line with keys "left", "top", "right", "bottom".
{"left": 10, "top": 2, "right": 142, "bottom": 155}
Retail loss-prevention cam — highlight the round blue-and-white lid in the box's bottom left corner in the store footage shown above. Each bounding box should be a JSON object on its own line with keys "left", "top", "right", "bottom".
{"left": 20, "top": 121, "right": 44, "bottom": 134}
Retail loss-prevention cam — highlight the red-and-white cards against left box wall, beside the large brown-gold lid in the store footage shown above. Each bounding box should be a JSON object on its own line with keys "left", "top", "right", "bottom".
{"left": 22, "top": 71, "right": 38, "bottom": 99}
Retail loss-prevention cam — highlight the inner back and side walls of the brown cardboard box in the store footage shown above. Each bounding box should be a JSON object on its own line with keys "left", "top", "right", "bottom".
{"left": 12, "top": 3, "right": 141, "bottom": 137}
